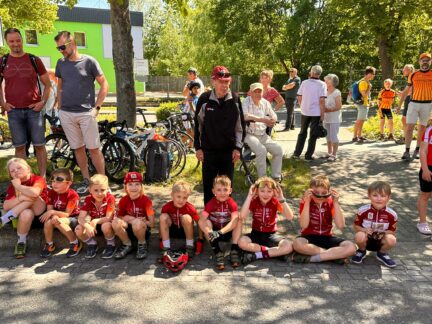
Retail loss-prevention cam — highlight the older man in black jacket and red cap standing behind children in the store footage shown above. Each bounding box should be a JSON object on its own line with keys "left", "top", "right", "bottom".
{"left": 195, "top": 66, "right": 245, "bottom": 204}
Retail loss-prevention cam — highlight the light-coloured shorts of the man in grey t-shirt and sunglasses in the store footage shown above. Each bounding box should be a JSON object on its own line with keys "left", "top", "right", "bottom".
{"left": 59, "top": 109, "right": 101, "bottom": 150}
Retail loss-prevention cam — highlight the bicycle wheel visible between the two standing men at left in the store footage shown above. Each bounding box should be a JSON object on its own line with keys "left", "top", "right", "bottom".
{"left": 45, "top": 133, "right": 76, "bottom": 174}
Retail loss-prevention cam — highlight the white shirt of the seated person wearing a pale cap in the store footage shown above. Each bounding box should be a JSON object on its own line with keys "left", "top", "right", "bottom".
{"left": 242, "top": 96, "right": 277, "bottom": 136}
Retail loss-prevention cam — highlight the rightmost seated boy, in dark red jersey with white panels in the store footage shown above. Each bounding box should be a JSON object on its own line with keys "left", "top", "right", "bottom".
{"left": 351, "top": 181, "right": 397, "bottom": 268}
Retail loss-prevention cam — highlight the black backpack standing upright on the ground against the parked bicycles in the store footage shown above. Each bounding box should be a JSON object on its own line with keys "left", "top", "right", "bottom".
{"left": 144, "top": 140, "right": 171, "bottom": 183}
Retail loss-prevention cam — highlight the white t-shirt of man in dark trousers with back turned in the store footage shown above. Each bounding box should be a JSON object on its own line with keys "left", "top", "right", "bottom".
{"left": 297, "top": 78, "right": 327, "bottom": 116}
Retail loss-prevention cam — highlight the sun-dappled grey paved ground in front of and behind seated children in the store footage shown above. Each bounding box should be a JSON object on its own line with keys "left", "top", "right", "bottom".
{"left": 0, "top": 112, "right": 432, "bottom": 323}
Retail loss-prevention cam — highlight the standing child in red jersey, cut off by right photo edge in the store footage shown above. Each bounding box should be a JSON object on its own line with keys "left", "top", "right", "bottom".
{"left": 417, "top": 119, "right": 432, "bottom": 235}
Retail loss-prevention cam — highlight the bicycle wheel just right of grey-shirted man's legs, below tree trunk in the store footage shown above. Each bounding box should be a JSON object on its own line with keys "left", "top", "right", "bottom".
{"left": 102, "top": 137, "right": 135, "bottom": 183}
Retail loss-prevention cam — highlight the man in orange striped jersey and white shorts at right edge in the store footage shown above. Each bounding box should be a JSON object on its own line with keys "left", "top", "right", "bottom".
{"left": 399, "top": 53, "right": 432, "bottom": 161}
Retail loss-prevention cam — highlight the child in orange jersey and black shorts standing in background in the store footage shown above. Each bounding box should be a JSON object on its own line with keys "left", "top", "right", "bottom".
{"left": 378, "top": 79, "right": 396, "bottom": 140}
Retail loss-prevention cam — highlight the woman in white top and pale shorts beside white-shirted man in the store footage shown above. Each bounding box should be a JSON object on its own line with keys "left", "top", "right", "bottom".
{"left": 324, "top": 74, "right": 342, "bottom": 161}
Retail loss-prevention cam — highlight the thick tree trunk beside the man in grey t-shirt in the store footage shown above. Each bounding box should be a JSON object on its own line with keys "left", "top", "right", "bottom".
{"left": 109, "top": 0, "right": 136, "bottom": 127}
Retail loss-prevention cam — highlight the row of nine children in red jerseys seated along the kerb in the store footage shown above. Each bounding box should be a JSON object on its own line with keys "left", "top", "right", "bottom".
{"left": 0, "top": 158, "right": 397, "bottom": 270}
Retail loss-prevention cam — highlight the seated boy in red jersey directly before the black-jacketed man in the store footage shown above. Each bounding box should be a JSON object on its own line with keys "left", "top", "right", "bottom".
{"left": 198, "top": 175, "right": 241, "bottom": 270}
